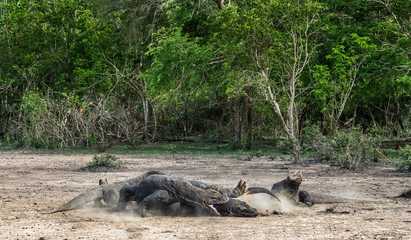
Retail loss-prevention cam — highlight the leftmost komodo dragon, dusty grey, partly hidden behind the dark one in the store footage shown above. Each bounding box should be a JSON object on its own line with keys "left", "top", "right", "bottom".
{"left": 45, "top": 171, "right": 165, "bottom": 214}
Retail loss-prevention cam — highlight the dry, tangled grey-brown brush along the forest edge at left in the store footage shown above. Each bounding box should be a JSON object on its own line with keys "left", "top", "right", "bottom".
{"left": 6, "top": 91, "right": 150, "bottom": 148}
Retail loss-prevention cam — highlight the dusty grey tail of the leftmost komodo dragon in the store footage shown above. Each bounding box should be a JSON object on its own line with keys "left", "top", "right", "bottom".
{"left": 43, "top": 186, "right": 107, "bottom": 214}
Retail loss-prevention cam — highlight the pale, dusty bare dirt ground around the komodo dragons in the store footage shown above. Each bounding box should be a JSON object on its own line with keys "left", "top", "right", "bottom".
{"left": 0, "top": 151, "right": 411, "bottom": 239}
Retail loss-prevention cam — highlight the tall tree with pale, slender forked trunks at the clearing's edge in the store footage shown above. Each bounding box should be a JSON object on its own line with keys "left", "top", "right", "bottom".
{"left": 217, "top": 0, "right": 321, "bottom": 161}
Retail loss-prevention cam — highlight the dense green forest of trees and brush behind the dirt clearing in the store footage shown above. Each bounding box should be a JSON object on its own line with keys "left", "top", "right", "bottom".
{"left": 0, "top": 0, "right": 411, "bottom": 167}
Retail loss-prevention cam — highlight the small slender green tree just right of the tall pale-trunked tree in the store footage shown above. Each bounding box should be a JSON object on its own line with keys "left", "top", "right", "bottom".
{"left": 311, "top": 34, "right": 376, "bottom": 131}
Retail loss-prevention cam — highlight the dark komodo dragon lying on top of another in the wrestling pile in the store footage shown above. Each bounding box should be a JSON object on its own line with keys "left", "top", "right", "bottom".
{"left": 113, "top": 175, "right": 229, "bottom": 217}
